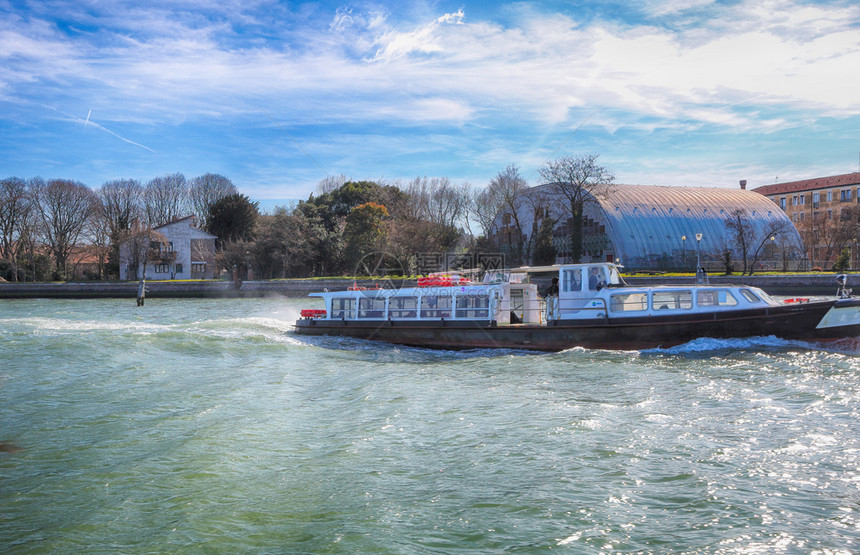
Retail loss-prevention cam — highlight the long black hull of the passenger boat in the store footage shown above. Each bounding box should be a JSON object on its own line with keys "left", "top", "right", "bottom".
{"left": 295, "top": 300, "right": 860, "bottom": 351}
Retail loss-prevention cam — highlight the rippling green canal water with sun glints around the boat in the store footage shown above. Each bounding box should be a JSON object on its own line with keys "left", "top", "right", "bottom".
{"left": 0, "top": 298, "right": 860, "bottom": 554}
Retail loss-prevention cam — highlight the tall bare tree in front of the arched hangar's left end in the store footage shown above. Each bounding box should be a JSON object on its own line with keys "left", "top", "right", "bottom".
{"left": 540, "top": 154, "right": 615, "bottom": 262}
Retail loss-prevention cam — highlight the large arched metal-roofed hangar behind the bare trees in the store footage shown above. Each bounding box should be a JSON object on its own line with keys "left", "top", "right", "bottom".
{"left": 496, "top": 184, "right": 803, "bottom": 270}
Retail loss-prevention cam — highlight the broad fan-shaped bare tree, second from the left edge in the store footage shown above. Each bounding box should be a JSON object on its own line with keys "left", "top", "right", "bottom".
{"left": 36, "top": 179, "right": 98, "bottom": 279}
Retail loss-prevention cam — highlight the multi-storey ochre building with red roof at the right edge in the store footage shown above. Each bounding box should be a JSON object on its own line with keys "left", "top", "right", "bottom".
{"left": 754, "top": 172, "right": 860, "bottom": 268}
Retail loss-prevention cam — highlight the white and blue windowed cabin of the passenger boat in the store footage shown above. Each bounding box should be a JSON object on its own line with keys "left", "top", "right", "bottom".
{"left": 303, "top": 262, "right": 778, "bottom": 326}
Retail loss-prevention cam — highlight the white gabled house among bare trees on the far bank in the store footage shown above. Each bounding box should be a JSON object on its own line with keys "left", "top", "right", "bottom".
{"left": 119, "top": 216, "right": 217, "bottom": 280}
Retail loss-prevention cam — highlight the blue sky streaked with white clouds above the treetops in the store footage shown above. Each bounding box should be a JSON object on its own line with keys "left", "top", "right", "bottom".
{"left": 0, "top": 0, "right": 860, "bottom": 202}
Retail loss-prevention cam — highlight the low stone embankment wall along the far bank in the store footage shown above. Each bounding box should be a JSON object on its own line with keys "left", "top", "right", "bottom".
{"left": 0, "top": 274, "right": 860, "bottom": 299}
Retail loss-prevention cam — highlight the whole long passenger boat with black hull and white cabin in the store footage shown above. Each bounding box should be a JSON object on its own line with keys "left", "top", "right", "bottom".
{"left": 295, "top": 262, "right": 860, "bottom": 351}
